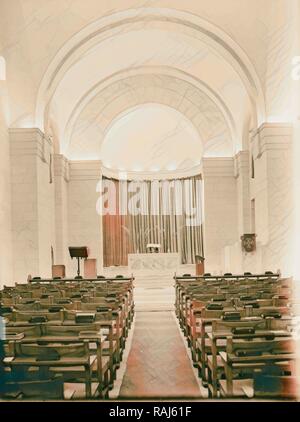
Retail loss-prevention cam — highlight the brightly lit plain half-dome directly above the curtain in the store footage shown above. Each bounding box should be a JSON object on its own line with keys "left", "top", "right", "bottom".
{"left": 100, "top": 103, "right": 203, "bottom": 172}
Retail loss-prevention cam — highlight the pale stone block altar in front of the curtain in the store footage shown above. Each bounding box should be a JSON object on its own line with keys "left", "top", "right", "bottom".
{"left": 128, "top": 253, "right": 180, "bottom": 276}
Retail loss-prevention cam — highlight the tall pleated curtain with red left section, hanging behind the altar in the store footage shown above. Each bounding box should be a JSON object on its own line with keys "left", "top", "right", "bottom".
{"left": 103, "top": 176, "right": 203, "bottom": 266}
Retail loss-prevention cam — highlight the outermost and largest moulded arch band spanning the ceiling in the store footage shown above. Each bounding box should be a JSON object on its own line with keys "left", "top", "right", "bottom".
{"left": 36, "top": 8, "right": 265, "bottom": 149}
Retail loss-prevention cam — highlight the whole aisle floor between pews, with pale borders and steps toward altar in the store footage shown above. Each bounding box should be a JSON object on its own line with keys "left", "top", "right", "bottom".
{"left": 110, "top": 266, "right": 205, "bottom": 400}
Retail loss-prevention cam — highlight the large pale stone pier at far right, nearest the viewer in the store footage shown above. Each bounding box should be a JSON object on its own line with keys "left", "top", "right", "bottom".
{"left": 251, "top": 123, "right": 293, "bottom": 276}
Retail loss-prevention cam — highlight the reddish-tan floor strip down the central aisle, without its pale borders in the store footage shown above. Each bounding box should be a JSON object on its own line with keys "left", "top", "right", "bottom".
{"left": 119, "top": 311, "right": 201, "bottom": 399}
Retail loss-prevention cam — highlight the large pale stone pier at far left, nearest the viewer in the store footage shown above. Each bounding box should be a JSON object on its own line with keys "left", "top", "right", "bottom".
{"left": 9, "top": 128, "right": 55, "bottom": 282}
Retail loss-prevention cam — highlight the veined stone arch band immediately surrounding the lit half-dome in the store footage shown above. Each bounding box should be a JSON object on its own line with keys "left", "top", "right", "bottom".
{"left": 62, "top": 69, "right": 235, "bottom": 158}
